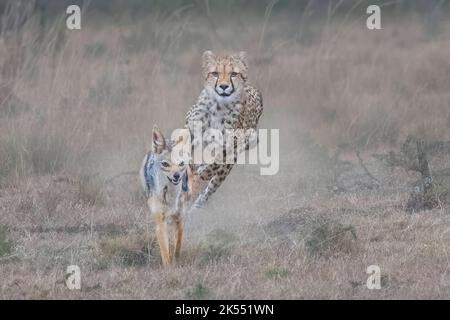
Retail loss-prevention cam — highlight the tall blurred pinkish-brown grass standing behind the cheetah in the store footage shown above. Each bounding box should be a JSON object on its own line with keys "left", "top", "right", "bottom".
{"left": 0, "top": 1, "right": 450, "bottom": 186}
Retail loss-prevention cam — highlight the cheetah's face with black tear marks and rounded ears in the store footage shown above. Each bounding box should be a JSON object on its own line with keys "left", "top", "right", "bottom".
{"left": 203, "top": 51, "right": 247, "bottom": 99}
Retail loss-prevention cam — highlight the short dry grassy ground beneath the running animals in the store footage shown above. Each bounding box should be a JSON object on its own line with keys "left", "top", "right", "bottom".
{"left": 0, "top": 146, "right": 450, "bottom": 299}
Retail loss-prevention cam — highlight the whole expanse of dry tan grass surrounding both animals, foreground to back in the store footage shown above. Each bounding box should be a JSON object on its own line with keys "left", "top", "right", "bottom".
{"left": 0, "top": 1, "right": 450, "bottom": 299}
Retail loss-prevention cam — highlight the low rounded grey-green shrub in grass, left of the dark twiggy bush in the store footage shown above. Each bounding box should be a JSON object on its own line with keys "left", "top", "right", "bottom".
{"left": 304, "top": 216, "right": 357, "bottom": 257}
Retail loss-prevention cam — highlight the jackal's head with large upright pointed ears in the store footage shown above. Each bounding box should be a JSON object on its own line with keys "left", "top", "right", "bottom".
{"left": 152, "top": 125, "right": 191, "bottom": 185}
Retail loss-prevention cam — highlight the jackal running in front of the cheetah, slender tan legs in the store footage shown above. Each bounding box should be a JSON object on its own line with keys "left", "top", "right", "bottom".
{"left": 139, "top": 125, "right": 190, "bottom": 266}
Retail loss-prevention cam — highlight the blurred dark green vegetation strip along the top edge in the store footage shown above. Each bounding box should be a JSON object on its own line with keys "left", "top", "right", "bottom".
{"left": 0, "top": 0, "right": 450, "bottom": 33}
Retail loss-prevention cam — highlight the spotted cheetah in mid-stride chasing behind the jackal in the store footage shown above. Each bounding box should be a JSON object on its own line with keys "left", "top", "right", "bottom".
{"left": 186, "top": 50, "right": 263, "bottom": 208}
